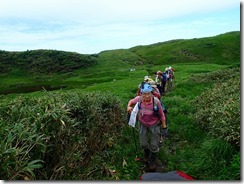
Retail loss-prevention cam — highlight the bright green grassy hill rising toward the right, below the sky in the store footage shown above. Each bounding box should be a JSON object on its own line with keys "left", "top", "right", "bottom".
{"left": 96, "top": 32, "right": 240, "bottom": 65}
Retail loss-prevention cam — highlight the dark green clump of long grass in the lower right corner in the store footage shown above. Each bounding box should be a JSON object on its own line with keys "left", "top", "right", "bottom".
{"left": 188, "top": 139, "right": 240, "bottom": 180}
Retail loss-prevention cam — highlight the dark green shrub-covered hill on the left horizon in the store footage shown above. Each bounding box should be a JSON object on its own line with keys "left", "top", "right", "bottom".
{"left": 0, "top": 50, "right": 96, "bottom": 75}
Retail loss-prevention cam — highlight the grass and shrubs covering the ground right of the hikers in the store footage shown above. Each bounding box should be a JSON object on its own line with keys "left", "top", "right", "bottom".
{"left": 158, "top": 67, "right": 240, "bottom": 180}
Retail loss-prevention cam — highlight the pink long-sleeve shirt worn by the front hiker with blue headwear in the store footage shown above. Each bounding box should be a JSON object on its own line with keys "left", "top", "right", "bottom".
{"left": 128, "top": 96, "right": 165, "bottom": 127}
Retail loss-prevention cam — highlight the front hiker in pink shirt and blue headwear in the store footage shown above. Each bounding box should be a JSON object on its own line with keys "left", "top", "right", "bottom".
{"left": 127, "top": 83, "right": 167, "bottom": 171}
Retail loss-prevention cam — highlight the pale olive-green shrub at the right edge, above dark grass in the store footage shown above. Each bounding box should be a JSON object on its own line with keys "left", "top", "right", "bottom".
{"left": 193, "top": 67, "right": 241, "bottom": 148}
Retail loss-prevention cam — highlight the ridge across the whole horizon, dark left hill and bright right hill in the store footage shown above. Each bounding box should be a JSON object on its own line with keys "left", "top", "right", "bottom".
{"left": 0, "top": 31, "right": 240, "bottom": 74}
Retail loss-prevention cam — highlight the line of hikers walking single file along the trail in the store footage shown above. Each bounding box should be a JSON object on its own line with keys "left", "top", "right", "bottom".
{"left": 127, "top": 67, "right": 174, "bottom": 171}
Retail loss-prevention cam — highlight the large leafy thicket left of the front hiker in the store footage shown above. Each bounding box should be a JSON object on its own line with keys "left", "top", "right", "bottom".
{"left": 0, "top": 92, "right": 124, "bottom": 180}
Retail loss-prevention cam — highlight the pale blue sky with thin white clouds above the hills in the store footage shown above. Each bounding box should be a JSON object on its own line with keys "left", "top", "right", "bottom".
{"left": 0, "top": 0, "right": 242, "bottom": 54}
